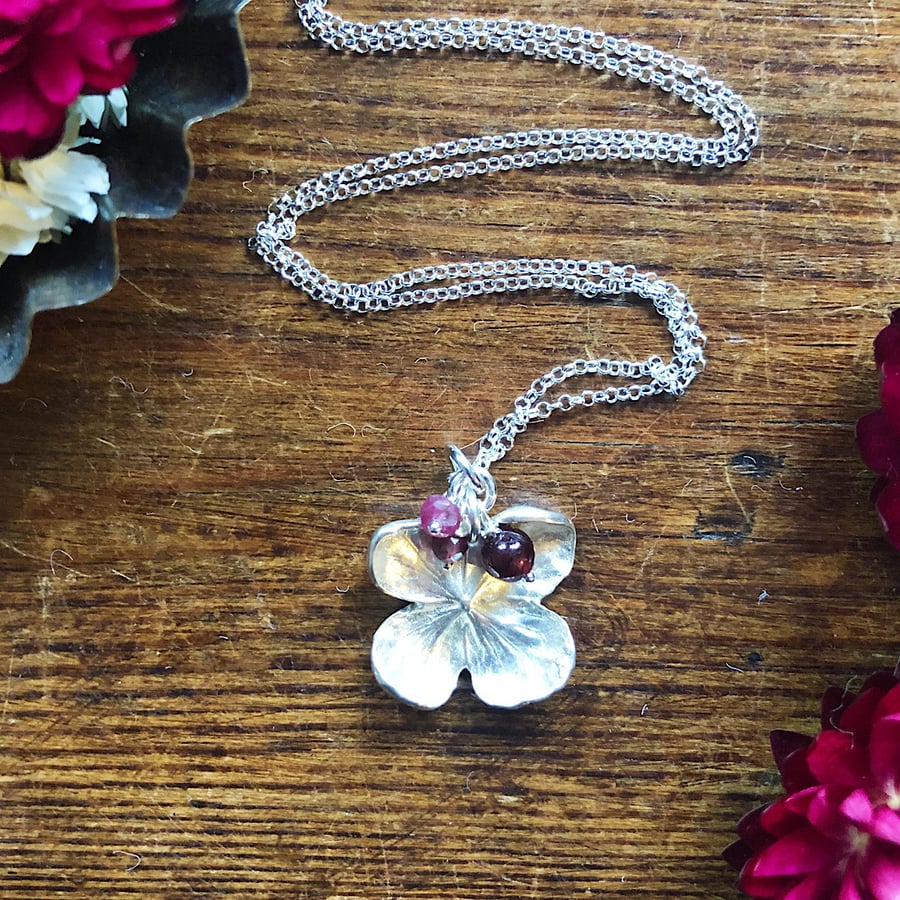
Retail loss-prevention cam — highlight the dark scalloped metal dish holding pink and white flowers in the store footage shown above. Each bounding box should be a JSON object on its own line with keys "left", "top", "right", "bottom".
{"left": 0, "top": 0, "right": 250, "bottom": 383}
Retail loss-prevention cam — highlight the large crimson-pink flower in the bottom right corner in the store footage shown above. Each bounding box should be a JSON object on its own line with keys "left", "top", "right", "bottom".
{"left": 723, "top": 665, "right": 900, "bottom": 900}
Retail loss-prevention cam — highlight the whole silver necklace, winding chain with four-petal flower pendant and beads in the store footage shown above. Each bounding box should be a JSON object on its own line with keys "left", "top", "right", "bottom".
{"left": 253, "top": 0, "right": 759, "bottom": 709}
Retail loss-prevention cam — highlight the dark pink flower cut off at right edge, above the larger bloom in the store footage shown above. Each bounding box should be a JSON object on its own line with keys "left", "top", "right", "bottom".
{"left": 856, "top": 310, "right": 900, "bottom": 550}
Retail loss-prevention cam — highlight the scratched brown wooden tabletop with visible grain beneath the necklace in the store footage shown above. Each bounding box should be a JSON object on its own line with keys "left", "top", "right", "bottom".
{"left": 0, "top": 0, "right": 900, "bottom": 900}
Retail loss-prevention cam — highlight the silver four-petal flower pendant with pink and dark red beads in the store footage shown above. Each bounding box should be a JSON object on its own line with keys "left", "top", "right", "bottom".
{"left": 369, "top": 448, "right": 575, "bottom": 709}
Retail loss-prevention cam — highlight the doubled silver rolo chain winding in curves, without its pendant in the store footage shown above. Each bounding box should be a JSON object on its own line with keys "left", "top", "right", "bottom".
{"left": 252, "top": 0, "right": 759, "bottom": 473}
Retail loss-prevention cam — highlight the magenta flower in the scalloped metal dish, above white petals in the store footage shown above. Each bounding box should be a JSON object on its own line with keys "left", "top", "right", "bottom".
{"left": 0, "top": 0, "right": 184, "bottom": 158}
